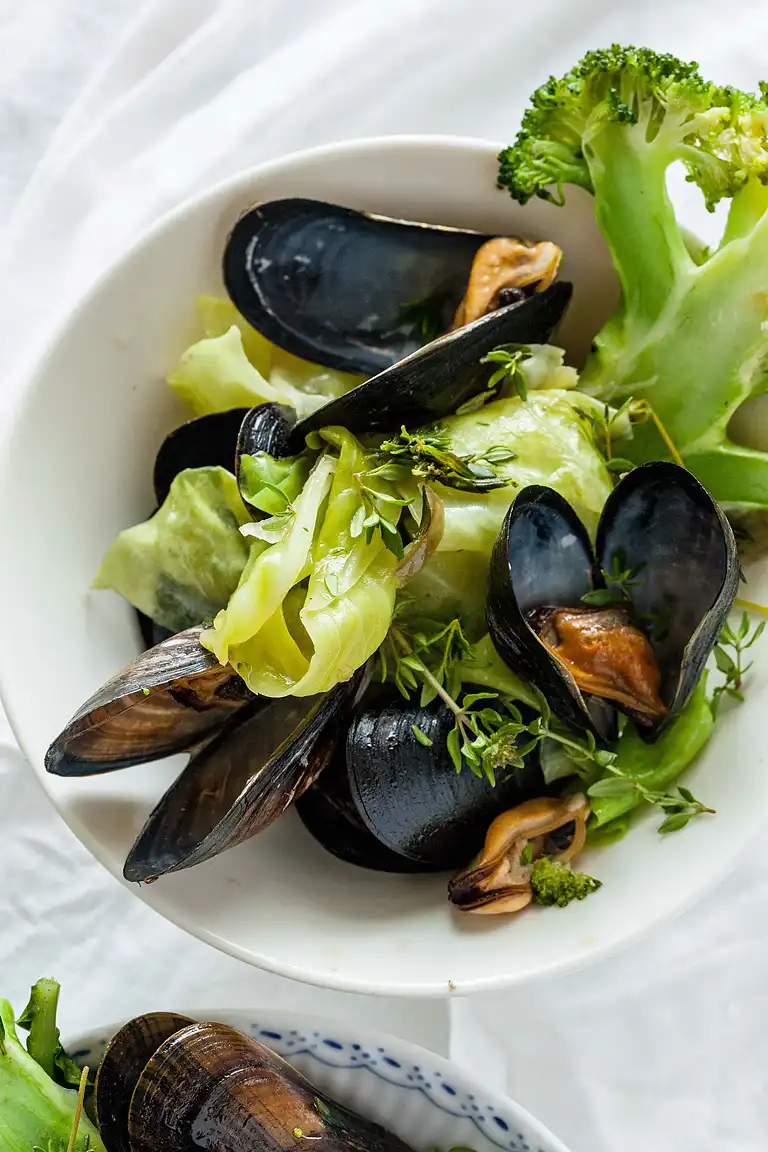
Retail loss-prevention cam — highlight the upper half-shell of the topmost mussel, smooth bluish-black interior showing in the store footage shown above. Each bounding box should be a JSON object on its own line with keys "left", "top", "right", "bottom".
{"left": 223, "top": 199, "right": 499, "bottom": 376}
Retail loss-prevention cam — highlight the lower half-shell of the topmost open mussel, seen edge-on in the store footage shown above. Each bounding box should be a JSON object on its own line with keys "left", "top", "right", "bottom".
{"left": 294, "top": 282, "right": 572, "bottom": 450}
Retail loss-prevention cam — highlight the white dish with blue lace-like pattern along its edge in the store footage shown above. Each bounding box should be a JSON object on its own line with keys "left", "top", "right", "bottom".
{"left": 68, "top": 1009, "right": 568, "bottom": 1152}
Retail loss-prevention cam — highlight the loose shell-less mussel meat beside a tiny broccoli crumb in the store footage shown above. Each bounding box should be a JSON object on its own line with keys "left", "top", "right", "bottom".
{"left": 448, "top": 793, "right": 590, "bottom": 915}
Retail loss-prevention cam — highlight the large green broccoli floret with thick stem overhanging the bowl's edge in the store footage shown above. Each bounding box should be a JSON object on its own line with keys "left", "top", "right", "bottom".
{"left": 499, "top": 45, "right": 768, "bottom": 508}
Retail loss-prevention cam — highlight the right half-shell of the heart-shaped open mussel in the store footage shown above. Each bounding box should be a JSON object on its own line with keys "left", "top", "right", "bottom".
{"left": 595, "top": 462, "right": 739, "bottom": 738}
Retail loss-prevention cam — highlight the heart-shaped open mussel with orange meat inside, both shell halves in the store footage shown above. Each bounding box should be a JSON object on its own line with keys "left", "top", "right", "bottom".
{"left": 486, "top": 462, "right": 739, "bottom": 740}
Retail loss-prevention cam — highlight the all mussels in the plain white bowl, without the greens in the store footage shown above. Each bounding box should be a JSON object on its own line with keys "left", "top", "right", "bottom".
{"left": 46, "top": 199, "right": 738, "bottom": 911}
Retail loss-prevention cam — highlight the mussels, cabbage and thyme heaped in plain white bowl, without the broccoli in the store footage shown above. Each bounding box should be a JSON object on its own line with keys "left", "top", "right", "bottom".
{"left": 46, "top": 188, "right": 738, "bottom": 914}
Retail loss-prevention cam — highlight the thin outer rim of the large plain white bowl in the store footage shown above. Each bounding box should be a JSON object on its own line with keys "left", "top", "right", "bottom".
{"left": 0, "top": 134, "right": 756, "bottom": 999}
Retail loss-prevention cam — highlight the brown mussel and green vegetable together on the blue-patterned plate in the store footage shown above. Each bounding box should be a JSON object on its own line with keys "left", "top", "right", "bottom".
{"left": 0, "top": 979, "right": 421, "bottom": 1152}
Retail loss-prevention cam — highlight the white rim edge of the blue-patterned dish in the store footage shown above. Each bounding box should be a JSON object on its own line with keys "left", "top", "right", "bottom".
{"left": 64, "top": 1007, "right": 569, "bottom": 1152}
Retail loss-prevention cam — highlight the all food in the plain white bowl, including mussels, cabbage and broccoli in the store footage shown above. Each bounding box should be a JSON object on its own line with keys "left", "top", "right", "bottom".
{"left": 46, "top": 47, "right": 768, "bottom": 916}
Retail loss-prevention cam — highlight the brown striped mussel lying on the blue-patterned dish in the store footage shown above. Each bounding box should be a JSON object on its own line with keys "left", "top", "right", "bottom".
{"left": 89, "top": 1013, "right": 421, "bottom": 1152}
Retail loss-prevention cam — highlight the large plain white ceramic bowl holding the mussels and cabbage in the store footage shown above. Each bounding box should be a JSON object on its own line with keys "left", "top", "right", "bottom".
{"left": 0, "top": 137, "right": 768, "bottom": 995}
